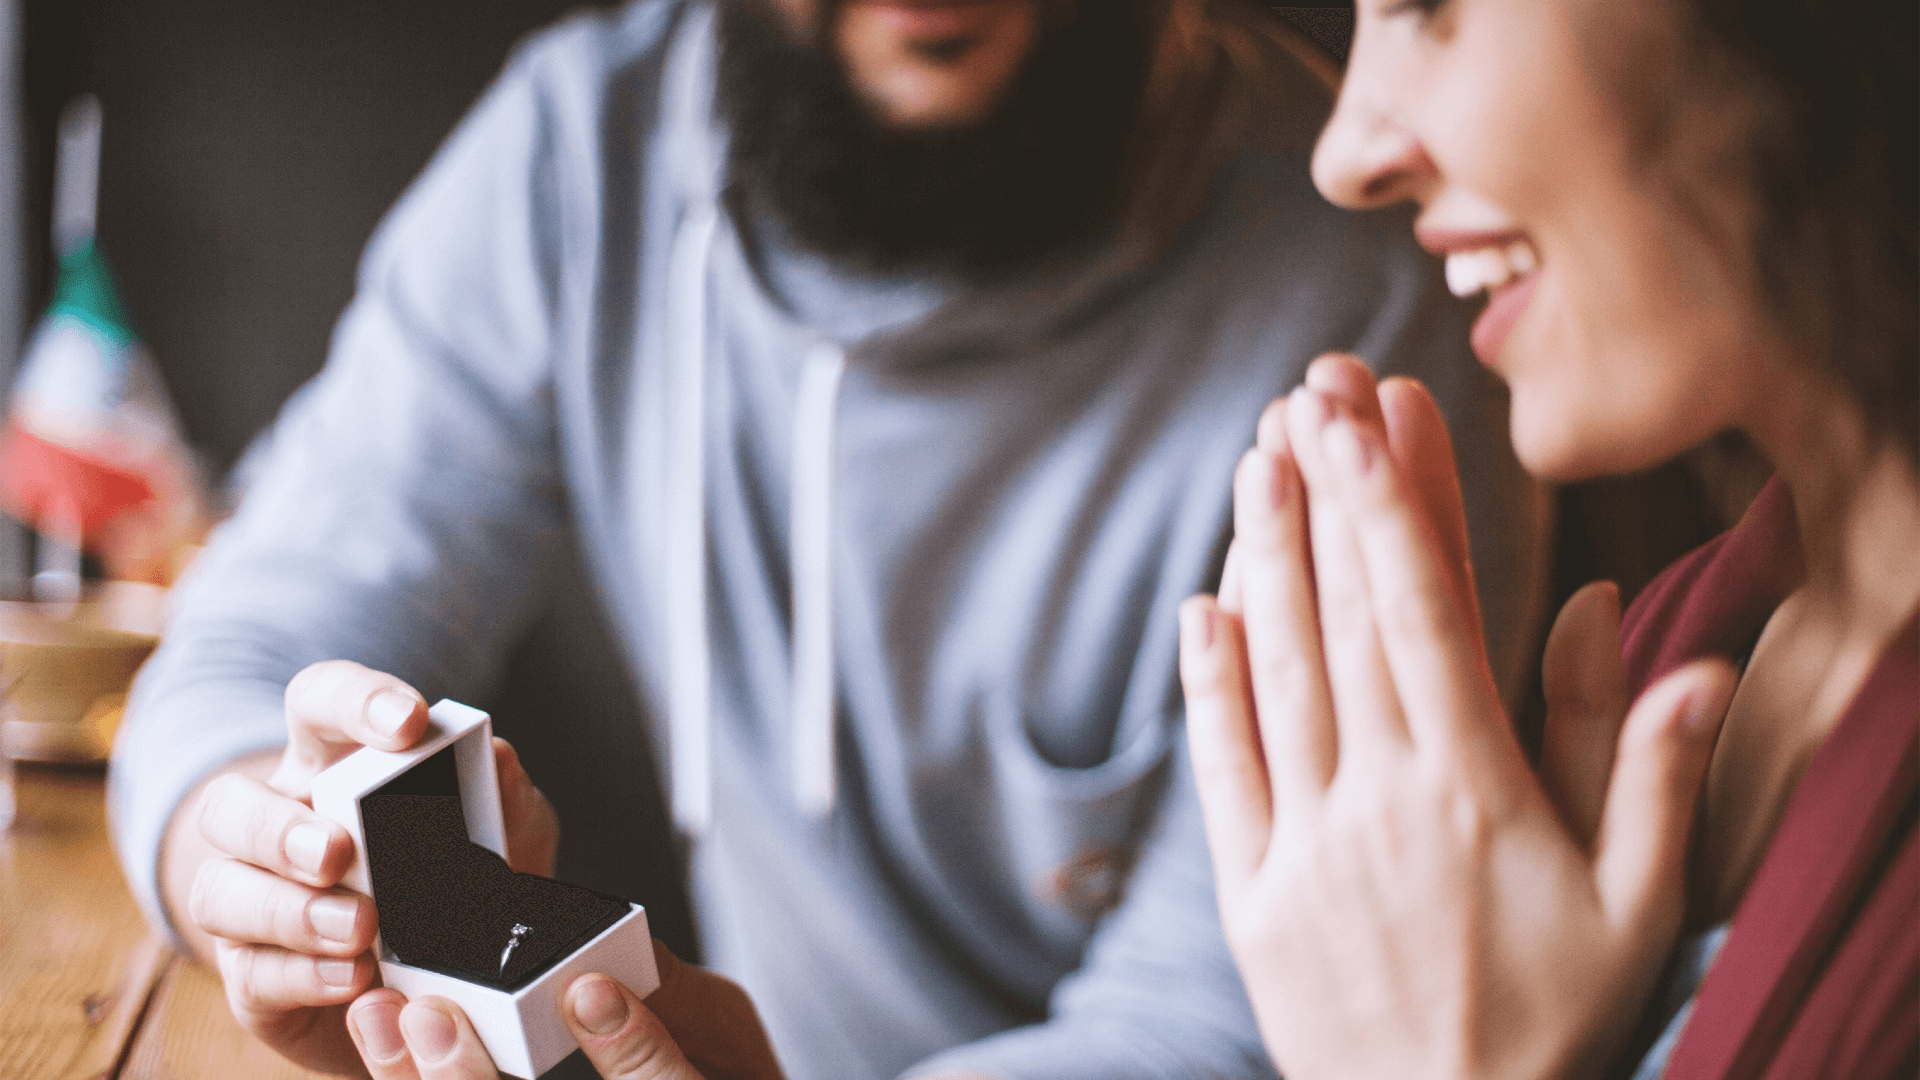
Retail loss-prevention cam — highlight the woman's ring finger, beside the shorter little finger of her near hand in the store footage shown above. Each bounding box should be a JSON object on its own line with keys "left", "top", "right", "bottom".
{"left": 1233, "top": 440, "right": 1338, "bottom": 817}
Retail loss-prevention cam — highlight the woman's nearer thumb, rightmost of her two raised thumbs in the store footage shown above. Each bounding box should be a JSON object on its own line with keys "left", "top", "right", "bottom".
{"left": 1594, "top": 659, "right": 1740, "bottom": 932}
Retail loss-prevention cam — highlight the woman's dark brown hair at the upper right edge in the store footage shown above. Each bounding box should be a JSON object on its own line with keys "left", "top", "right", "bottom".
{"left": 1680, "top": 0, "right": 1920, "bottom": 465}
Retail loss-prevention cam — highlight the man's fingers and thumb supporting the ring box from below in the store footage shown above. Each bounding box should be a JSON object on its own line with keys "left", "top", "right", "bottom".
{"left": 348, "top": 942, "right": 780, "bottom": 1080}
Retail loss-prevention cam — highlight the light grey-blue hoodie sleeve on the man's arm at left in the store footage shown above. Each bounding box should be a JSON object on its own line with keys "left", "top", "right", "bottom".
{"left": 109, "top": 29, "right": 583, "bottom": 930}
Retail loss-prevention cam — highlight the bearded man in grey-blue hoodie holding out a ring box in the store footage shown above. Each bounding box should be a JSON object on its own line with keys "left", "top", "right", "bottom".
{"left": 113, "top": 0, "right": 1540, "bottom": 1080}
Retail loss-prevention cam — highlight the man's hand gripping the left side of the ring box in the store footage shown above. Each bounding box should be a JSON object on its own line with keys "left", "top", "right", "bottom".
{"left": 167, "top": 661, "right": 559, "bottom": 1072}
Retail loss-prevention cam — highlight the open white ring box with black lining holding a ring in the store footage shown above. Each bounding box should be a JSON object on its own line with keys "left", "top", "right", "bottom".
{"left": 313, "top": 701, "right": 660, "bottom": 1076}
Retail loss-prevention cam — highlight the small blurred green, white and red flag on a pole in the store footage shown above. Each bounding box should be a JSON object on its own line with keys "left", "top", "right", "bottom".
{"left": 0, "top": 94, "right": 205, "bottom": 601}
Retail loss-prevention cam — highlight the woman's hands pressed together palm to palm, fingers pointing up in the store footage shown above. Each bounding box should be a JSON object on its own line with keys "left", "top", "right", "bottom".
{"left": 1181, "top": 356, "right": 1734, "bottom": 1080}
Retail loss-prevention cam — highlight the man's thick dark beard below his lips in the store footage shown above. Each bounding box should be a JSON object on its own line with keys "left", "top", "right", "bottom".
{"left": 718, "top": 0, "right": 1150, "bottom": 281}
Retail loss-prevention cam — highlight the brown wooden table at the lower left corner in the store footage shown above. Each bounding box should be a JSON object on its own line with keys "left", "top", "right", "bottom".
{"left": 0, "top": 765, "right": 337, "bottom": 1080}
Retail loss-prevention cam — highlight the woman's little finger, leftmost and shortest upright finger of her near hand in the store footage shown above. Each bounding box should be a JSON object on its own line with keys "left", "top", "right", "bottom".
{"left": 1181, "top": 596, "right": 1273, "bottom": 897}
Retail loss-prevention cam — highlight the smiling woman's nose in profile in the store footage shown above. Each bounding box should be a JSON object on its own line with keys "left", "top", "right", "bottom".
{"left": 1313, "top": 81, "right": 1436, "bottom": 209}
